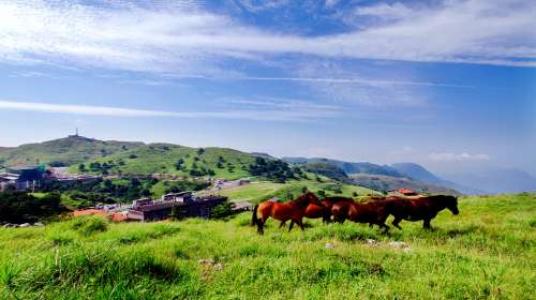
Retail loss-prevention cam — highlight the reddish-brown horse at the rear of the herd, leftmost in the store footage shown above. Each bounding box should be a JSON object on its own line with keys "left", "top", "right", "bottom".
{"left": 251, "top": 193, "right": 321, "bottom": 234}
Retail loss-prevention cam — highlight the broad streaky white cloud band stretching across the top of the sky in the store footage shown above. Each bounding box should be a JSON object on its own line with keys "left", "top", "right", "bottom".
{"left": 0, "top": 0, "right": 536, "bottom": 74}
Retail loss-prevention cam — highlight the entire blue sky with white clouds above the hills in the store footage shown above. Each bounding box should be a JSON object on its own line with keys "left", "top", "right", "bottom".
{"left": 0, "top": 0, "right": 536, "bottom": 174}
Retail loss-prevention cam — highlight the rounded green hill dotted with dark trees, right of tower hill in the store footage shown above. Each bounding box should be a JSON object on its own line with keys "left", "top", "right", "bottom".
{"left": 69, "top": 144, "right": 302, "bottom": 182}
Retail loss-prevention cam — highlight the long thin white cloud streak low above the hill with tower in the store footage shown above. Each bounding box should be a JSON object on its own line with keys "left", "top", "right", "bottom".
{"left": 0, "top": 100, "right": 336, "bottom": 122}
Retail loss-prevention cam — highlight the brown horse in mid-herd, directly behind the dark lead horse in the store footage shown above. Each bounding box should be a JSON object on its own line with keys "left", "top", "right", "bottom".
{"left": 331, "top": 200, "right": 389, "bottom": 233}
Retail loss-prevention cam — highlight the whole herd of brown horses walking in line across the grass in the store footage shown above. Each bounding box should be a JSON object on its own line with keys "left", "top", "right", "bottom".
{"left": 251, "top": 192, "right": 459, "bottom": 234}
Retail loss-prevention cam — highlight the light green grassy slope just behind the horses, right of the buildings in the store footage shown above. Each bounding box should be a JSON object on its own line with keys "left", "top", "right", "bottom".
{"left": 220, "top": 177, "right": 373, "bottom": 203}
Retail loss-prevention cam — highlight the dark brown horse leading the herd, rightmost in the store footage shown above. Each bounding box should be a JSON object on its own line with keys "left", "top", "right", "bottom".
{"left": 385, "top": 195, "right": 459, "bottom": 229}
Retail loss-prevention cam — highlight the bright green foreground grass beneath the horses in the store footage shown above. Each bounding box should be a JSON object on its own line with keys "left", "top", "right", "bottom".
{"left": 0, "top": 190, "right": 536, "bottom": 299}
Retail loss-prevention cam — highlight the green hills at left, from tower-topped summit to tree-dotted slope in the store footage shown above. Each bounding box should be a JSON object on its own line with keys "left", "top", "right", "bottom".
{"left": 0, "top": 135, "right": 301, "bottom": 181}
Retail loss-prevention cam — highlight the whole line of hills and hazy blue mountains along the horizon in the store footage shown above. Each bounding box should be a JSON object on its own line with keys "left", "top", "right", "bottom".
{"left": 0, "top": 135, "right": 536, "bottom": 194}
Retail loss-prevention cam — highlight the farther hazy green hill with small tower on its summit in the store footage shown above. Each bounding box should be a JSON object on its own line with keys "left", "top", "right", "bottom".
{"left": 0, "top": 136, "right": 143, "bottom": 166}
